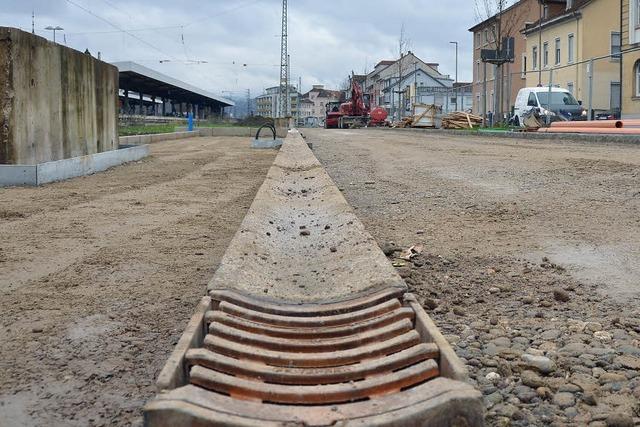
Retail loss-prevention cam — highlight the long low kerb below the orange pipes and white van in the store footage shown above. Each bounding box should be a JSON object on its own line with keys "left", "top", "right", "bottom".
{"left": 370, "top": 128, "right": 640, "bottom": 145}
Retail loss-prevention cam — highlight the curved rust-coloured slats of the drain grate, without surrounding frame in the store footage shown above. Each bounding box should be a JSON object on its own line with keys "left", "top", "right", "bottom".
{"left": 180, "top": 289, "right": 440, "bottom": 405}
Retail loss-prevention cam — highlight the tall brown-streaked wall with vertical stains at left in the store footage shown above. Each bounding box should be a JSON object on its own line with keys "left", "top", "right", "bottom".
{"left": 0, "top": 27, "right": 118, "bottom": 165}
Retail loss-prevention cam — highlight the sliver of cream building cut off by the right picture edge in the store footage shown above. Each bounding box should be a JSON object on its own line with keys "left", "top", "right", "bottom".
{"left": 621, "top": 0, "right": 640, "bottom": 119}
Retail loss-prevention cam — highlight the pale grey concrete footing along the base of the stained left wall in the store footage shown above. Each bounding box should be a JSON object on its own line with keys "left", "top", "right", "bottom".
{"left": 0, "top": 145, "right": 149, "bottom": 187}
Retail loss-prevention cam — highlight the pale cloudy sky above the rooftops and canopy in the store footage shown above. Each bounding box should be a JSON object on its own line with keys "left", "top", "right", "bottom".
{"left": 0, "top": 0, "right": 492, "bottom": 96}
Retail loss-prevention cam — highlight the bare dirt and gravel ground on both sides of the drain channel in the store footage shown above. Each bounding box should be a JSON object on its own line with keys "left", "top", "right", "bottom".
{"left": 0, "top": 129, "right": 640, "bottom": 427}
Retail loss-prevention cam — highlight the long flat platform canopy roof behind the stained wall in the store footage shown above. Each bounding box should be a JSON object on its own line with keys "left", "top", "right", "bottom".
{"left": 112, "top": 62, "right": 235, "bottom": 107}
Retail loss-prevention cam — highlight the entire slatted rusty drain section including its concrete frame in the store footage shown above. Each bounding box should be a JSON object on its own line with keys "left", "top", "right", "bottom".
{"left": 145, "top": 288, "right": 482, "bottom": 427}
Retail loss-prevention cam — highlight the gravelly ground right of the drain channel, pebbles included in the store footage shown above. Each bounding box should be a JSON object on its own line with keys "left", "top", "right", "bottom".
{"left": 304, "top": 129, "right": 640, "bottom": 426}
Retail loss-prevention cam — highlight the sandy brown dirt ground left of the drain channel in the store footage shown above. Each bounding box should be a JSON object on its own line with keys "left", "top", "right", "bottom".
{"left": 0, "top": 138, "right": 276, "bottom": 427}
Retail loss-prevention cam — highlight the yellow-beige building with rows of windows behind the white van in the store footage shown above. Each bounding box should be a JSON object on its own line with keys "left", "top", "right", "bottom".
{"left": 522, "top": 0, "right": 621, "bottom": 115}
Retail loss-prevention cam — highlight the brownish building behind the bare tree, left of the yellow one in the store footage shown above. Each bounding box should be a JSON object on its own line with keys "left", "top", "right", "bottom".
{"left": 469, "top": 0, "right": 564, "bottom": 115}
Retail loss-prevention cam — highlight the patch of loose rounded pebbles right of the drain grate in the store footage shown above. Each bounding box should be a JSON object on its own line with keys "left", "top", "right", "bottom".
{"left": 382, "top": 243, "right": 640, "bottom": 427}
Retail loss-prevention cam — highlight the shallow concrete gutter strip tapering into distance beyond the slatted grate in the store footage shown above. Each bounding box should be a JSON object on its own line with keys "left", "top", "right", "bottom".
{"left": 209, "top": 131, "right": 406, "bottom": 302}
